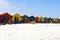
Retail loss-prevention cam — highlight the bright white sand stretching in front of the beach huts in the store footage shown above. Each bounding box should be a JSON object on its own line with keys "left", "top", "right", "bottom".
{"left": 0, "top": 24, "right": 60, "bottom": 40}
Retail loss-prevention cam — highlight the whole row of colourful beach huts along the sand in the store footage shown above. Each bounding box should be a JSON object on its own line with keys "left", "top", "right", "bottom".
{"left": 0, "top": 13, "right": 60, "bottom": 25}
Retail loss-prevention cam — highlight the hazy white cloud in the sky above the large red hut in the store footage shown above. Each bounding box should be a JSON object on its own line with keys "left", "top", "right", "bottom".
{"left": 0, "top": 0, "right": 18, "bottom": 14}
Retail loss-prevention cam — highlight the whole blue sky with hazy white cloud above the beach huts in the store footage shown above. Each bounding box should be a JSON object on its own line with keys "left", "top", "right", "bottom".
{"left": 0, "top": 0, "right": 60, "bottom": 18}
